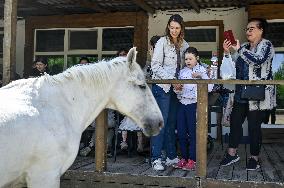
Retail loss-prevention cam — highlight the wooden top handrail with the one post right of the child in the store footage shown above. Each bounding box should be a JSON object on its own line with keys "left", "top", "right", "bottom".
{"left": 147, "top": 79, "right": 284, "bottom": 178}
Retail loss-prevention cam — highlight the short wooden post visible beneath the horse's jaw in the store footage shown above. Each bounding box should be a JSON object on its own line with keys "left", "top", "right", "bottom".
{"left": 95, "top": 110, "right": 108, "bottom": 172}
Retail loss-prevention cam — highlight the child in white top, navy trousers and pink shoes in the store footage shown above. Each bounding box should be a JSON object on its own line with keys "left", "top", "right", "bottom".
{"left": 174, "top": 47, "right": 213, "bottom": 170}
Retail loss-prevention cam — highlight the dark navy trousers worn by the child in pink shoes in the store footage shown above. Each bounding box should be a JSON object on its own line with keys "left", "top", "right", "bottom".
{"left": 177, "top": 103, "right": 197, "bottom": 161}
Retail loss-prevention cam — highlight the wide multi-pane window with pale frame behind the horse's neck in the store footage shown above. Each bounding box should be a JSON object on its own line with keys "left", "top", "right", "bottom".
{"left": 34, "top": 27, "right": 134, "bottom": 73}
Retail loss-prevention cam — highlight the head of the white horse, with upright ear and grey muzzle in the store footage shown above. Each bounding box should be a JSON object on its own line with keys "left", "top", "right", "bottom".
{"left": 109, "top": 47, "right": 163, "bottom": 136}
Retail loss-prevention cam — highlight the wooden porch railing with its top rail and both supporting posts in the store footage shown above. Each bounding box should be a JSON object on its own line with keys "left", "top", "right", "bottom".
{"left": 95, "top": 79, "right": 284, "bottom": 178}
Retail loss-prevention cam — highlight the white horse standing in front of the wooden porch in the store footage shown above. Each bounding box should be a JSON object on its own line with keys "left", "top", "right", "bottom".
{"left": 0, "top": 48, "right": 163, "bottom": 188}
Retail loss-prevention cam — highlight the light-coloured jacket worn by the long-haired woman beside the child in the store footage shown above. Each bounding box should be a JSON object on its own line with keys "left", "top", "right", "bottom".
{"left": 151, "top": 36, "right": 189, "bottom": 93}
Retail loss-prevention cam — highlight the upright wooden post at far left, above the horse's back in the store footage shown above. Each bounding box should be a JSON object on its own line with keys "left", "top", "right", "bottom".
{"left": 3, "top": 0, "right": 17, "bottom": 86}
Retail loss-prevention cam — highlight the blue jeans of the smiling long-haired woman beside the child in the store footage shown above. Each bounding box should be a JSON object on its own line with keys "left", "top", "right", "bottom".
{"left": 151, "top": 84, "right": 178, "bottom": 161}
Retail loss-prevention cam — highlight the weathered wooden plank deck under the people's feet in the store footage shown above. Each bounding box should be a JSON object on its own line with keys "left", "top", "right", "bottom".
{"left": 61, "top": 143, "right": 284, "bottom": 188}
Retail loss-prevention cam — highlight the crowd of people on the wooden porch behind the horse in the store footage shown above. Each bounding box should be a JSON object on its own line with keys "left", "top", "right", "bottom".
{"left": 1, "top": 14, "right": 276, "bottom": 171}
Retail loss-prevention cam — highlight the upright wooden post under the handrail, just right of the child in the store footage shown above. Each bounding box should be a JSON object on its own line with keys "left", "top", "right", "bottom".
{"left": 196, "top": 84, "right": 208, "bottom": 178}
